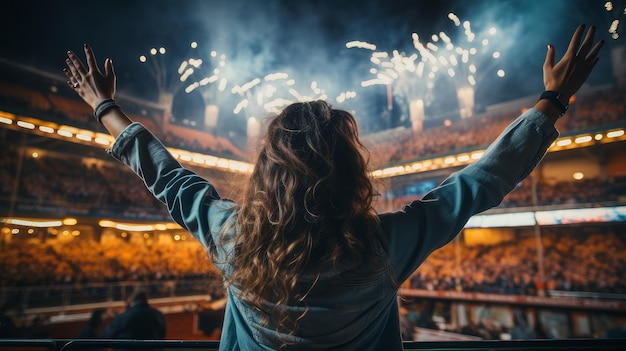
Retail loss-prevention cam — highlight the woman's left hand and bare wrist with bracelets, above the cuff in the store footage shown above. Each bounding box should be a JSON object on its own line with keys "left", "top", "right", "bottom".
{"left": 63, "top": 44, "right": 131, "bottom": 138}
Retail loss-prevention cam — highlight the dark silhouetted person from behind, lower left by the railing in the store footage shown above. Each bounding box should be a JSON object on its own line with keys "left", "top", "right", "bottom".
{"left": 101, "top": 291, "right": 166, "bottom": 350}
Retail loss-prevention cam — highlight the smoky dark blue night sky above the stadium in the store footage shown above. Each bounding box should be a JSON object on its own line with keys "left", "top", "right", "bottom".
{"left": 0, "top": 0, "right": 626, "bottom": 142}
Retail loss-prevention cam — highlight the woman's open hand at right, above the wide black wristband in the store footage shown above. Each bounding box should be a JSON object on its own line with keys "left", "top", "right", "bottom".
{"left": 543, "top": 24, "right": 604, "bottom": 98}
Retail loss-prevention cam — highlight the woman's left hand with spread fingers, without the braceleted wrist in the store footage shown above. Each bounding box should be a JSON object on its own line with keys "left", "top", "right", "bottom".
{"left": 63, "top": 44, "right": 116, "bottom": 109}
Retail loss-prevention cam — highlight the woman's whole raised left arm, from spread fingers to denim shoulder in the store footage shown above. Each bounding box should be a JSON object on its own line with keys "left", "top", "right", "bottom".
{"left": 63, "top": 45, "right": 232, "bottom": 253}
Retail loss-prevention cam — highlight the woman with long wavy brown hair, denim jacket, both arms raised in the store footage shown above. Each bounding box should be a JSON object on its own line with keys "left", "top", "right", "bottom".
{"left": 64, "top": 25, "right": 602, "bottom": 350}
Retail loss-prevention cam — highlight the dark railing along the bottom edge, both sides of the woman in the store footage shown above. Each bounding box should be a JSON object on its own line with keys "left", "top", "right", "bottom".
{"left": 0, "top": 339, "right": 626, "bottom": 351}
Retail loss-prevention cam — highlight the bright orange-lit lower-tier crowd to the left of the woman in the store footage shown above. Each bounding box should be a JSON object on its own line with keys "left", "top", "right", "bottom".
{"left": 0, "top": 234, "right": 217, "bottom": 287}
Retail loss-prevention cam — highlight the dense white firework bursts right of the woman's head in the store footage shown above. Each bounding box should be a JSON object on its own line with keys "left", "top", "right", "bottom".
{"left": 346, "top": 13, "right": 505, "bottom": 117}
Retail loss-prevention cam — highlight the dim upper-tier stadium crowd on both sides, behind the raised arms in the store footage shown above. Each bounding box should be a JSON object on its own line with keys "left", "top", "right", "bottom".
{"left": 0, "top": 68, "right": 626, "bottom": 167}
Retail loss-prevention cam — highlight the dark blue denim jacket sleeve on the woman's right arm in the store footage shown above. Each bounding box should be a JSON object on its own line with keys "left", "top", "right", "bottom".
{"left": 381, "top": 109, "right": 558, "bottom": 283}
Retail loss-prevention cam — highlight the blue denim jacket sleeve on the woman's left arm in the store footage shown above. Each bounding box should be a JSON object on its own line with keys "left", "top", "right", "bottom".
{"left": 109, "top": 122, "right": 234, "bottom": 247}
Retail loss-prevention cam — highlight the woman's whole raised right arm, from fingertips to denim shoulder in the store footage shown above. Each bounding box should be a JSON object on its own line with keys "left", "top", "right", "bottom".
{"left": 381, "top": 26, "right": 602, "bottom": 282}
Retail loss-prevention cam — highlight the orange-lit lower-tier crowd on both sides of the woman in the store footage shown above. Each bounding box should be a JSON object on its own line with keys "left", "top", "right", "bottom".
{"left": 0, "top": 227, "right": 626, "bottom": 295}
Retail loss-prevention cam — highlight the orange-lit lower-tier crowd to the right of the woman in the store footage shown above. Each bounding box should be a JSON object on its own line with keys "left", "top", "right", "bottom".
{"left": 410, "top": 228, "right": 626, "bottom": 295}
